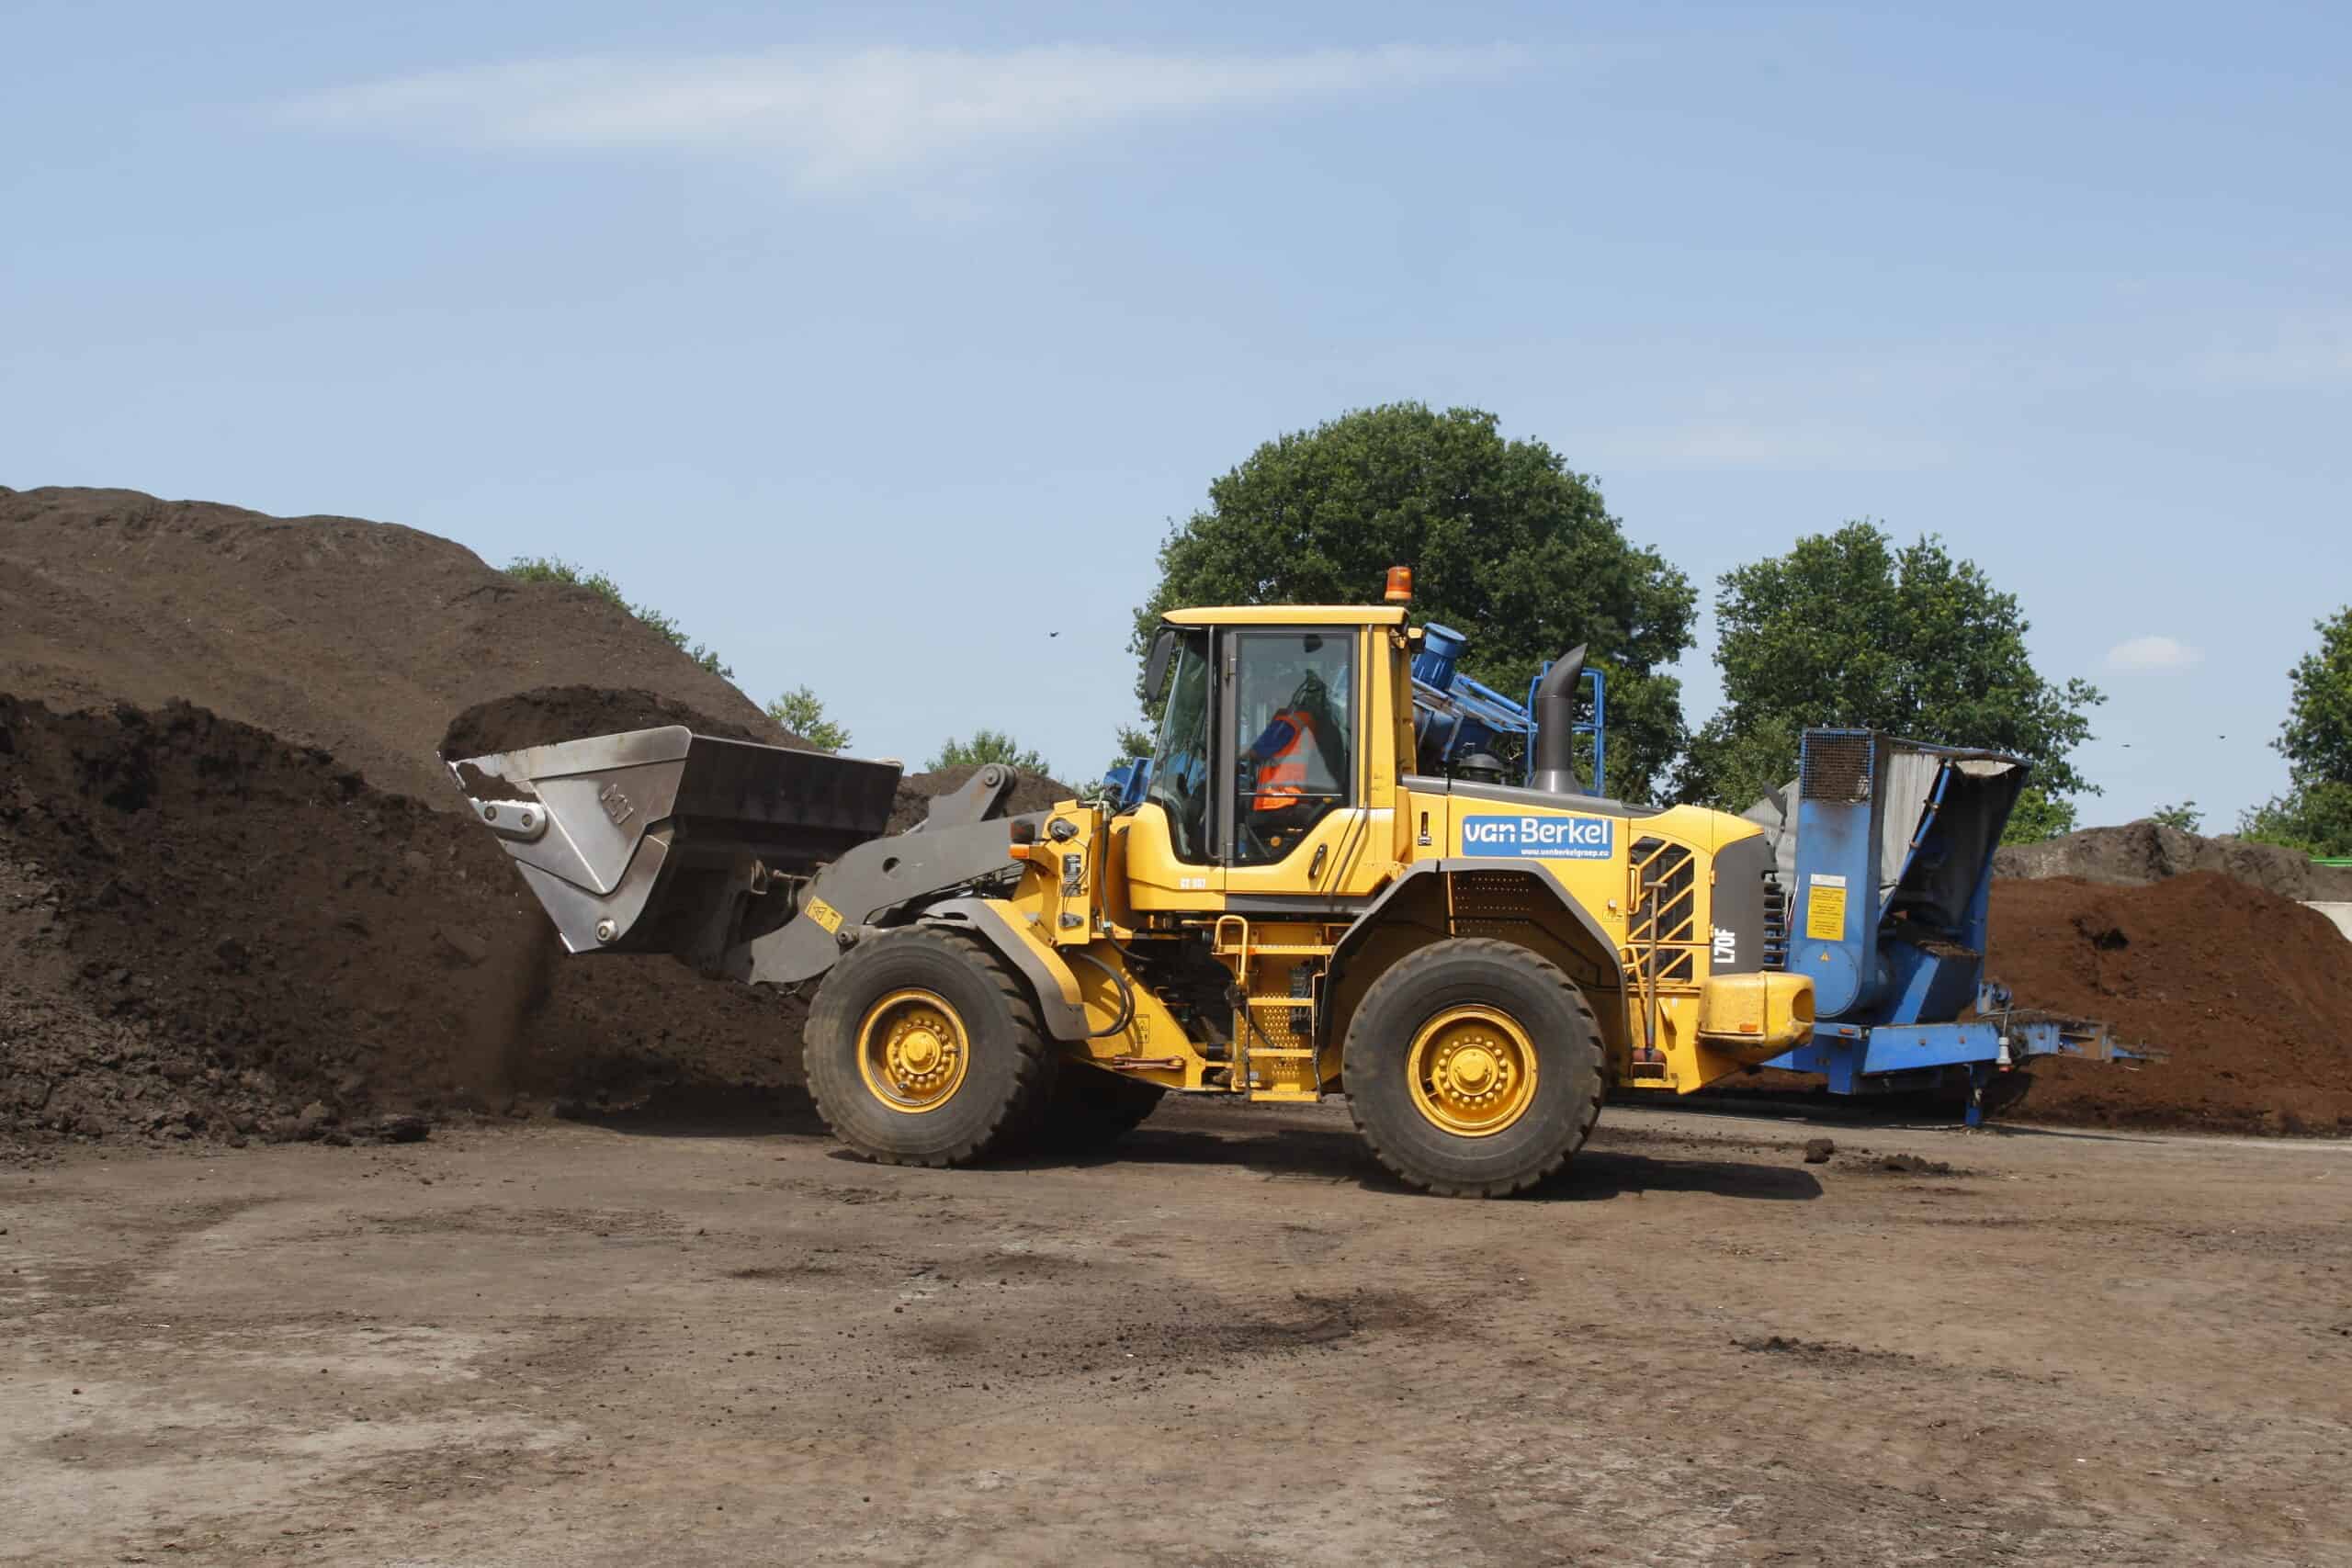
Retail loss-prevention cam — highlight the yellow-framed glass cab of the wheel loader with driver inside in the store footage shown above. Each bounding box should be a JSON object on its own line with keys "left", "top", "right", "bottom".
{"left": 1131, "top": 606, "right": 1402, "bottom": 898}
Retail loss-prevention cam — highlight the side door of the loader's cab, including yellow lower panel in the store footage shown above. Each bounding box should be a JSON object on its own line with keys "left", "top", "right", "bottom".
{"left": 1211, "top": 626, "right": 1390, "bottom": 893}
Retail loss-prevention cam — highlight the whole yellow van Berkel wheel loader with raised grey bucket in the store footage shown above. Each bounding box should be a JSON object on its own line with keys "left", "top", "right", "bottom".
{"left": 449, "top": 573, "right": 1814, "bottom": 1197}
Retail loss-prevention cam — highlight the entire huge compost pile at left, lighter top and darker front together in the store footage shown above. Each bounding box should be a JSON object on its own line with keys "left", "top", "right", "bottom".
{"left": 0, "top": 491, "right": 828, "bottom": 1138}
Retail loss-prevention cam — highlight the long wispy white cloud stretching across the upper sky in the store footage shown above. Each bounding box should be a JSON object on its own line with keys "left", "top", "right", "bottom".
{"left": 282, "top": 45, "right": 1517, "bottom": 186}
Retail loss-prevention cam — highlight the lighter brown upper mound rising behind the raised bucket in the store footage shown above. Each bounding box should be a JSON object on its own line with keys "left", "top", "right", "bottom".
{"left": 0, "top": 487, "right": 786, "bottom": 811}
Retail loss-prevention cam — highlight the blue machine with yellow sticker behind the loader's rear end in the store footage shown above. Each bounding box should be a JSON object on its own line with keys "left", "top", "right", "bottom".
{"left": 1747, "top": 728, "right": 2141, "bottom": 1126}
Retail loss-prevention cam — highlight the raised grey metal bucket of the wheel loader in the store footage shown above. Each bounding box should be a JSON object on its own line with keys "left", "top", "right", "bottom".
{"left": 449, "top": 724, "right": 899, "bottom": 957}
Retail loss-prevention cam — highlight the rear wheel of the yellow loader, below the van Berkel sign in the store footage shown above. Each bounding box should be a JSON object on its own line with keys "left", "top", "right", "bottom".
{"left": 1340, "top": 938, "right": 1601, "bottom": 1197}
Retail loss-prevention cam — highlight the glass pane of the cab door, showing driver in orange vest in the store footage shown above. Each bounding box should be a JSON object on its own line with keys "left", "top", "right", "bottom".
{"left": 1232, "top": 632, "right": 1355, "bottom": 865}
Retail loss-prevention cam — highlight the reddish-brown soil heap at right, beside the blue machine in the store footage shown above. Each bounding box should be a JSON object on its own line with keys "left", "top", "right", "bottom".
{"left": 1987, "top": 872, "right": 2352, "bottom": 1134}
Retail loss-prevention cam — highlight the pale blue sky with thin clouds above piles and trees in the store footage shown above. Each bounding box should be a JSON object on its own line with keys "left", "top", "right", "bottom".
{"left": 0, "top": 0, "right": 2352, "bottom": 825}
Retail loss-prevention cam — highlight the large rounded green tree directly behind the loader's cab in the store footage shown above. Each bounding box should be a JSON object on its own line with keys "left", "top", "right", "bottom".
{"left": 1131, "top": 402, "right": 1696, "bottom": 795}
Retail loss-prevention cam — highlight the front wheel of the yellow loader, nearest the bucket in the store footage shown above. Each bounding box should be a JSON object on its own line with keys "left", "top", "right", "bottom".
{"left": 802, "top": 926, "right": 1054, "bottom": 1166}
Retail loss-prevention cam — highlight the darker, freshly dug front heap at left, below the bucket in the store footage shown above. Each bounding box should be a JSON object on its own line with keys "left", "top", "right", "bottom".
{"left": 0, "top": 698, "right": 805, "bottom": 1138}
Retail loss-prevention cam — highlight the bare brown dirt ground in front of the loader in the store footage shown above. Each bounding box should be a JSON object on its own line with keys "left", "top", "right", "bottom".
{"left": 0, "top": 1105, "right": 2352, "bottom": 1568}
